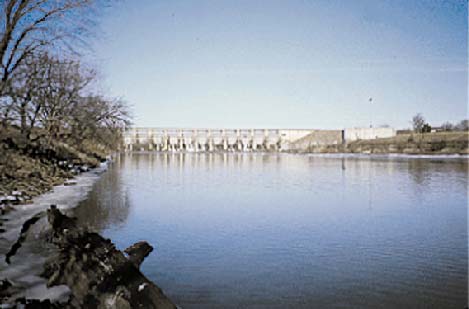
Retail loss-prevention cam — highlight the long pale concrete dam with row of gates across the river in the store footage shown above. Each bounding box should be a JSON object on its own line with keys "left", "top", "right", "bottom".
{"left": 123, "top": 127, "right": 396, "bottom": 152}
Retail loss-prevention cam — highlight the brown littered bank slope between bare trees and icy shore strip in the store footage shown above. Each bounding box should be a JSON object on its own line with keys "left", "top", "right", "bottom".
{"left": 0, "top": 128, "right": 107, "bottom": 210}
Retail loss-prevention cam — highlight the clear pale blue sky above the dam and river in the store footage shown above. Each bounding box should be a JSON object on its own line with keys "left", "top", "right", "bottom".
{"left": 89, "top": 0, "right": 468, "bottom": 129}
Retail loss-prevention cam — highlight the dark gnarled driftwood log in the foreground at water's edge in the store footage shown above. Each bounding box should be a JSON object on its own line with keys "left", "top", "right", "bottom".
{"left": 43, "top": 206, "right": 176, "bottom": 308}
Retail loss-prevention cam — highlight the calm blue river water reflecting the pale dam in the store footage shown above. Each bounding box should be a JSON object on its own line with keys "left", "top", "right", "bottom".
{"left": 75, "top": 153, "right": 468, "bottom": 309}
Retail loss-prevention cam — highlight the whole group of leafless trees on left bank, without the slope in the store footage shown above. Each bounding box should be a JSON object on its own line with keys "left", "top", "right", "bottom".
{"left": 0, "top": 0, "right": 130, "bottom": 152}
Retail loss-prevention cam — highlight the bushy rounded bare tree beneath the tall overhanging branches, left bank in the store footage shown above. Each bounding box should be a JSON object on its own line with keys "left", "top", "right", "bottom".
{"left": 6, "top": 53, "right": 94, "bottom": 137}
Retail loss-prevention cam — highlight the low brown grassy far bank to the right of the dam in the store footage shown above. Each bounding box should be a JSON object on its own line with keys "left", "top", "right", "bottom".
{"left": 291, "top": 132, "right": 469, "bottom": 155}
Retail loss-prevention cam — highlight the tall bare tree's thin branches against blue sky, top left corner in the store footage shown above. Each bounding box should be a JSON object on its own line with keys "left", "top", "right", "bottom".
{"left": 0, "top": 0, "right": 93, "bottom": 95}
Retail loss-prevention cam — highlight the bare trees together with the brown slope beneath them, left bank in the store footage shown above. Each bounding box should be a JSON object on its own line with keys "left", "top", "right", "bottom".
{"left": 0, "top": 0, "right": 130, "bottom": 204}
